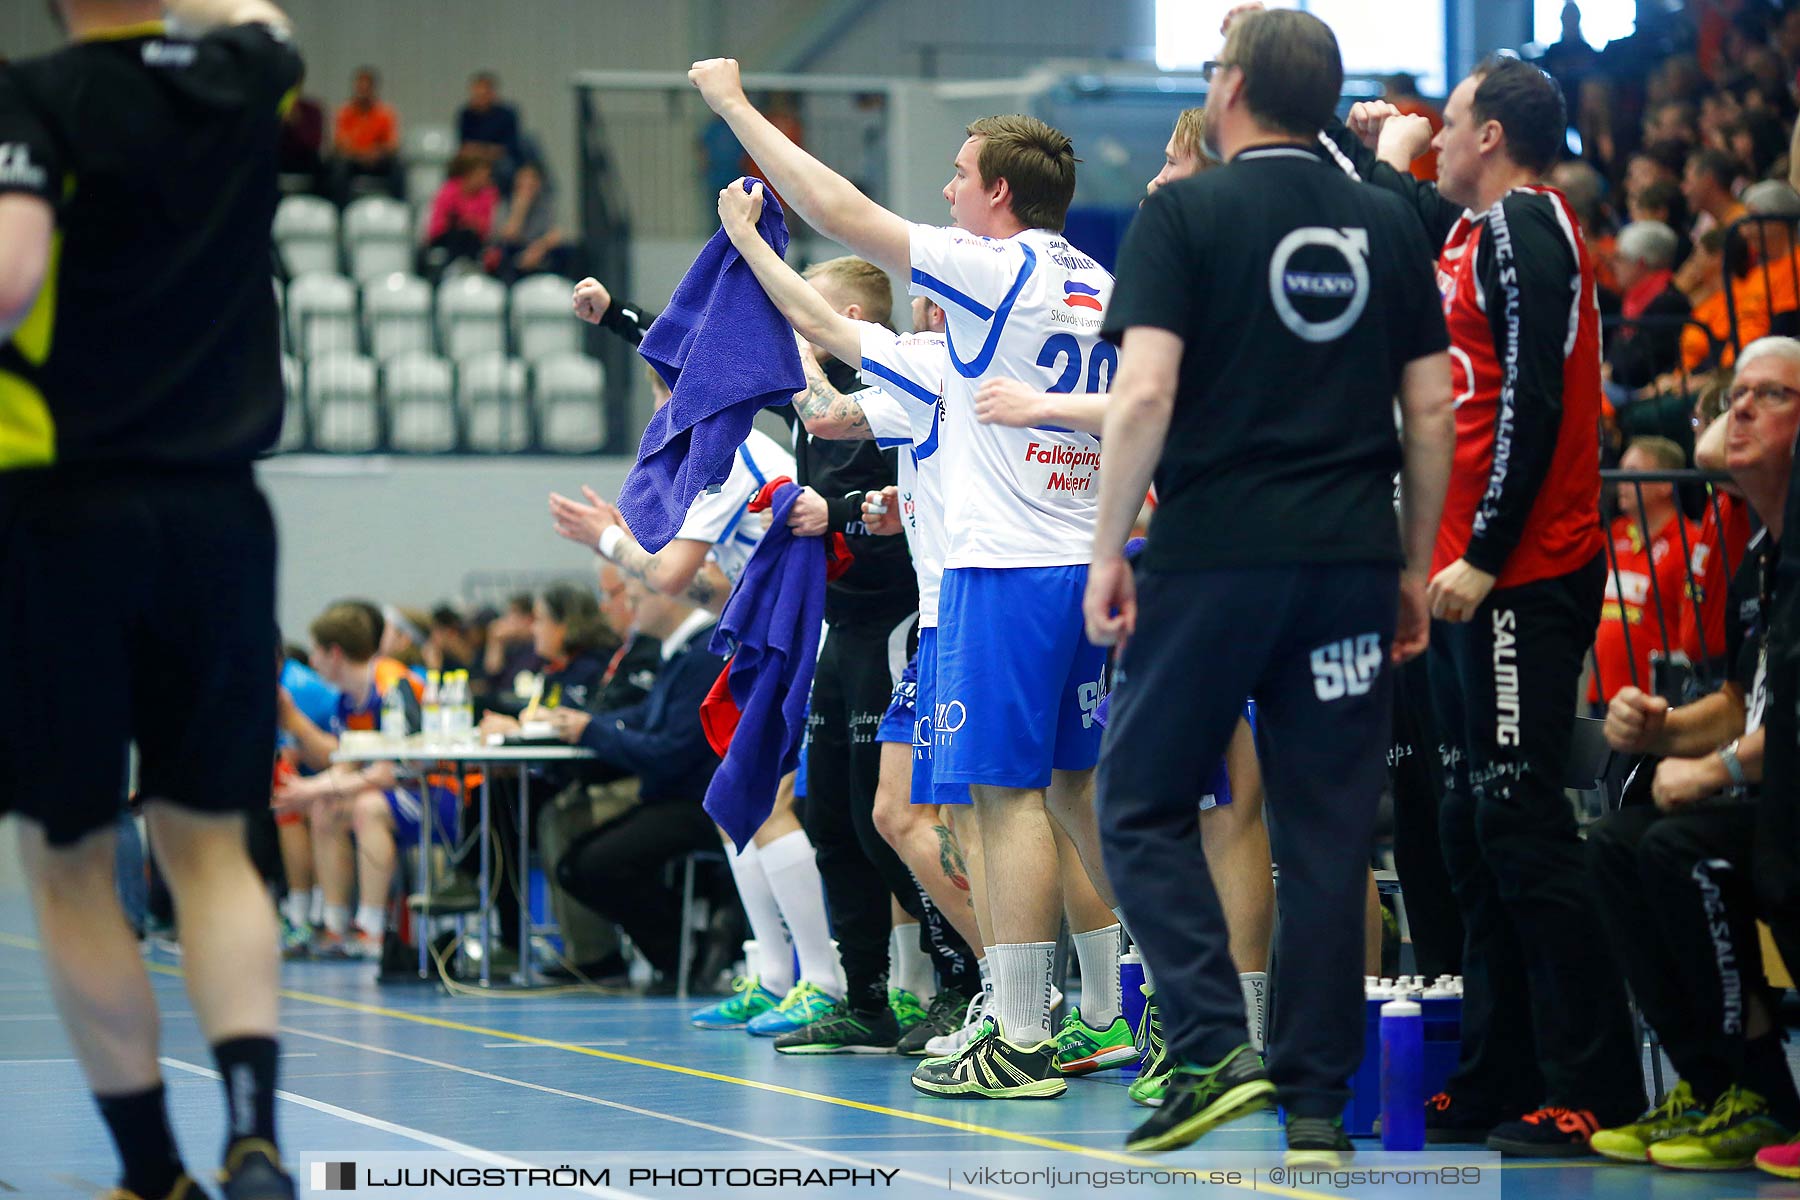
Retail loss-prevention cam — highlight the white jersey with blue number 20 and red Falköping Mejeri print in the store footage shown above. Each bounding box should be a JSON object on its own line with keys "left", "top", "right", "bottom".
{"left": 911, "top": 225, "right": 1118, "bottom": 567}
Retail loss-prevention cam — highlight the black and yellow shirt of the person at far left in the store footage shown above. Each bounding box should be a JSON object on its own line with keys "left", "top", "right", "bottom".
{"left": 0, "top": 25, "right": 301, "bottom": 479}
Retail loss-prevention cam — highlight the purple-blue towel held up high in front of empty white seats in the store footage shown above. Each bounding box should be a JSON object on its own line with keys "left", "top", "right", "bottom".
{"left": 619, "top": 187, "right": 806, "bottom": 554}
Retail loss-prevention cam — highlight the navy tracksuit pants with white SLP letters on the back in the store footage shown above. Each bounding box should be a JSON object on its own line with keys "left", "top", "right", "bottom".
{"left": 1098, "top": 565, "right": 1399, "bottom": 1117}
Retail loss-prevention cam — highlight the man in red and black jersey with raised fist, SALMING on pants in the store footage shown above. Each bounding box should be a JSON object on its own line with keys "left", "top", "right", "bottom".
{"left": 1330, "top": 58, "right": 1643, "bottom": 1157}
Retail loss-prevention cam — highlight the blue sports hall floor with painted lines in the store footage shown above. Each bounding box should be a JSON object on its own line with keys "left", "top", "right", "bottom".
{"left": 0, "top": 894, "right": 1800, "bottom": 1200}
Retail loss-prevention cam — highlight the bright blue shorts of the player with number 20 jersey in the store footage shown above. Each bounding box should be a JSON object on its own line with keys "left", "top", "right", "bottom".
{"left": 922, "top": 567, "right": 1107, "bottom": 788}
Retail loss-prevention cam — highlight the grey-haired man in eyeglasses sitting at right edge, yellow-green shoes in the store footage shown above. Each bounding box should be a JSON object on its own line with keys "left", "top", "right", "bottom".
{"left": 1588, "top": 338, "right": 1800, "bottom": 1171}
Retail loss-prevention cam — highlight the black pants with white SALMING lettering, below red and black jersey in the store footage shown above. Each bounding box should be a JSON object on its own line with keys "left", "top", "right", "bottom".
{"left": 1429, "top": 556, "right": 1643, "bottom": 1126}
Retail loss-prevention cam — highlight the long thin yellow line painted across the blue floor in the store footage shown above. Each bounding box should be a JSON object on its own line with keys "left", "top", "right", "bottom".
{"left": 0, "top": 932, "right": 1548, "bottom": 1200}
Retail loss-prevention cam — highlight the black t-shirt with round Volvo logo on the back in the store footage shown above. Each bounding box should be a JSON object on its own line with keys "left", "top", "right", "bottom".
{"left": 1103, "top": 146, "right": 1449, "bottom": 570}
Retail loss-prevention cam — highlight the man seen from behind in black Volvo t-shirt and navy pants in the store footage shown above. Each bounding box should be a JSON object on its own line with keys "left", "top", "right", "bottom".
{"left": 1087, "top": 11, "right": 1453, "bottom": 1144}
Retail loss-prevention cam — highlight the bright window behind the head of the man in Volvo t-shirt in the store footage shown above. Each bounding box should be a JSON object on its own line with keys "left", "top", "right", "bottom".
{"left": 1156, "top": 0, "right": 1447, "bottom": 95}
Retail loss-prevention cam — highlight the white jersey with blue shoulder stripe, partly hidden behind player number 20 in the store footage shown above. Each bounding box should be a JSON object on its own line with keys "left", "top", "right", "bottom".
{"left": 859, "top": 322, "right": 949, "bottom": 630}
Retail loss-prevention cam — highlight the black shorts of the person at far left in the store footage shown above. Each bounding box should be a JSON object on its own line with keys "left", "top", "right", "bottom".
{"left": 0, "top": 466, "right": 275, "bottom": 846}
